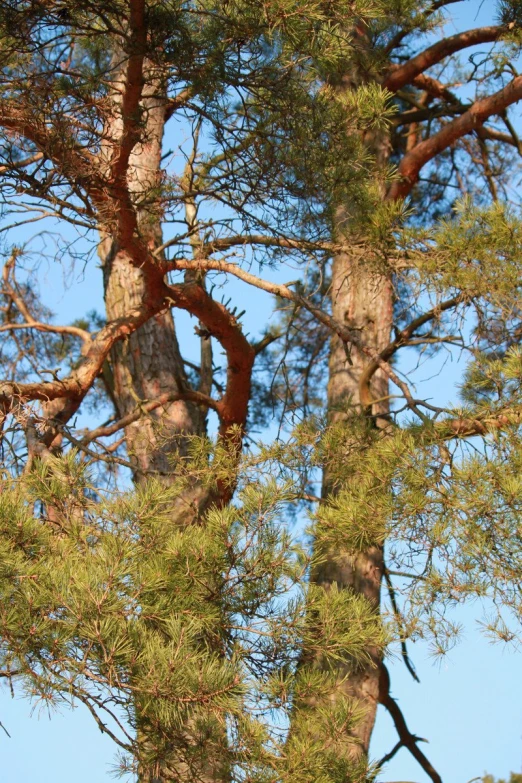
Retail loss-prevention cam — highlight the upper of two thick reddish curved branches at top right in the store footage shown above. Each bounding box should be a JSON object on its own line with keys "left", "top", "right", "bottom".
{"left": 383, "top": 25, "right": 507, "bottom": 92}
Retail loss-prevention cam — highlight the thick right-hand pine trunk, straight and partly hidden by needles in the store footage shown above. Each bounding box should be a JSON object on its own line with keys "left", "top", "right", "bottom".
{"left": 312, "top": 236, "right": 392, "bottom": 760}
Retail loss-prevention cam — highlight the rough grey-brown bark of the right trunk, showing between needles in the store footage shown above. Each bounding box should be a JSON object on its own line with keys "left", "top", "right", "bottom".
{"left": 306, "top": 27, "right": 393, "bottom": 762}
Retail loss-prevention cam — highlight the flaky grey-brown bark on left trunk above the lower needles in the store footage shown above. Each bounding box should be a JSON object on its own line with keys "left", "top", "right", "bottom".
{"left": 99, "top": 64, "right": 201, "bottom": 479}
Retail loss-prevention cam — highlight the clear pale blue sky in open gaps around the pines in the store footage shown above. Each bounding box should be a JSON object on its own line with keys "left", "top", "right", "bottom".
{"left": 0, "top": 0, "right": 522, "bottom": 783}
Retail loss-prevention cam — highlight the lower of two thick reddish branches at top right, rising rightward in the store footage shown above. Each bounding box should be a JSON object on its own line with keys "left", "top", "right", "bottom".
{"left": 387, "top": 76, "right": 522, "bottom": 200}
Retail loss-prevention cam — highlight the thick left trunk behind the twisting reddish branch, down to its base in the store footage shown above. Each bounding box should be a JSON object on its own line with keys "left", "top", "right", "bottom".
{"left": 98, "top": 62, "right": 228, "bottom": 783}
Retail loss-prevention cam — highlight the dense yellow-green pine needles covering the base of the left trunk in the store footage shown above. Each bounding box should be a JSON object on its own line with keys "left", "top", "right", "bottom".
{"left": 0, "top": 453, "right": 382, "bottom": 781}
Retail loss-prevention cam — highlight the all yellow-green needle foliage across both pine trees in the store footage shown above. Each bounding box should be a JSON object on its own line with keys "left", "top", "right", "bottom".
{"left": 5, "top": 0, "right": 522, "bottom": 783}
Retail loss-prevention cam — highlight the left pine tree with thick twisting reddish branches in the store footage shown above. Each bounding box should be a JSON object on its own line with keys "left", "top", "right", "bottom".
{"left": 0, "top": 0, "right": 381, "bottom": 782}
